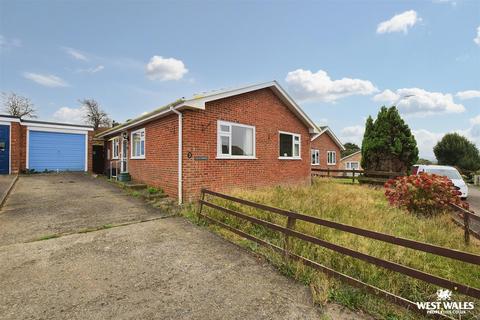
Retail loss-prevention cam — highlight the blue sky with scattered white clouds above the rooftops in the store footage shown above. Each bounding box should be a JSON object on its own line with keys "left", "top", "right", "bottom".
{"left": 0, "top": 0, "right": 480, "bottom": 159}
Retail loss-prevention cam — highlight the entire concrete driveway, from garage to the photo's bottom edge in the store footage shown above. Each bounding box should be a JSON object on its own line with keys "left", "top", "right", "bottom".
{"left": 0, "top": 175, "right": 356, "bottom": 320}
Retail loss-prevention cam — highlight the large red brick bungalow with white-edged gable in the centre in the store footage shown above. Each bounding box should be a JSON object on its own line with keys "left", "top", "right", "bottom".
{"left": 97, "top": 81, "right": 320, "bottom": 203}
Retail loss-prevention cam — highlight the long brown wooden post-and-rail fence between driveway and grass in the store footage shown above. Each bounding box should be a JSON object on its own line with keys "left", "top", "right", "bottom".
{"left": 198, "top": 189, "right": 480, "bottom": 318}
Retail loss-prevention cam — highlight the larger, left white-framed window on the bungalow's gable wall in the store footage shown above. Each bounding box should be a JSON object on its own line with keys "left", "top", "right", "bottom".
{"left": 217, "top": 120, "right": 255, "bottom": 159}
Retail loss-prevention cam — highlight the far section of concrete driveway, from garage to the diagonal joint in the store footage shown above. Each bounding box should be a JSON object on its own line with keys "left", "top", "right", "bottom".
{"left": 0, "top": 173, "right": 164, "bottom": 245}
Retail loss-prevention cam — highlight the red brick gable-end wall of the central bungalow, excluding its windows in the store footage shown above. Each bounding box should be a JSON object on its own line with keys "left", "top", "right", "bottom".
{"left": 183, "top": 89, "right": 310, "bottom": 201}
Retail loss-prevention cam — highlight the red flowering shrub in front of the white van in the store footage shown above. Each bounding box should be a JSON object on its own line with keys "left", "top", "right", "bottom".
{"left": 385, "top": 172, "right": 468, "bottom": 216}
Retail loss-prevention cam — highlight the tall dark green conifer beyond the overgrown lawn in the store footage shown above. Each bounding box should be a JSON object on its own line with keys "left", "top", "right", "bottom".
{"left": 362, "top": 106, "right": 418, "bottom": 172}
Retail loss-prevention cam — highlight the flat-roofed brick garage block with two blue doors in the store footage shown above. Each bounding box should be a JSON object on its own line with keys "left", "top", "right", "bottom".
{"left": 0, "top": 115, "right": 93, "bottom": 174}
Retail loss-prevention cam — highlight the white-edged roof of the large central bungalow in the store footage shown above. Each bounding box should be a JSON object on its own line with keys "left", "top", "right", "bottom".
{"left": 97, "top": 81, "right": 321, "bottom": 137}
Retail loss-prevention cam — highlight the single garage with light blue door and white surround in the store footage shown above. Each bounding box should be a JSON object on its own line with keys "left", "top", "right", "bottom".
{"left": 27, "top": 121, "right": 93, "bottom": 172}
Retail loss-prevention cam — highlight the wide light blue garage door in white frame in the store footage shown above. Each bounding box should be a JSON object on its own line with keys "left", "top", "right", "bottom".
{"left": 28, "top": 130, "right": 85, "bottom": 171}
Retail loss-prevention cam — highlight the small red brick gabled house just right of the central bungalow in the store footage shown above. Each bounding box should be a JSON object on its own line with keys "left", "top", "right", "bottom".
{"left": 311, "top": 126, "right": 345, "bottom": 169}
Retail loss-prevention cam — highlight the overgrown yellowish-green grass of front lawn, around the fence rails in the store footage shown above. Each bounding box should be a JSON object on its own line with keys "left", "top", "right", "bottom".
{"left": 184, "top": 179, "right": 480, "bottom": 319}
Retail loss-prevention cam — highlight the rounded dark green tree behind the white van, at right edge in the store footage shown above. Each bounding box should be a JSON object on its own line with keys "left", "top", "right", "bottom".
{"left": 433, "top": 133, "right": 480, "bottom": 173}
